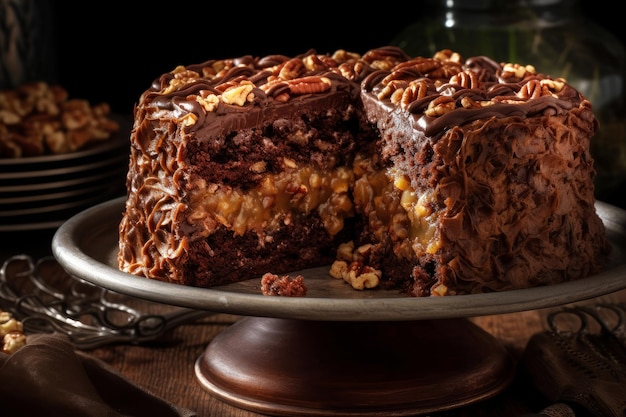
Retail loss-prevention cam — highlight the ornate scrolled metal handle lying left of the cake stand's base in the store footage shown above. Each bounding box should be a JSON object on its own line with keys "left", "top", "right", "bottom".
{"left": 0, "top": 255, "right": 214, "bottom": 349}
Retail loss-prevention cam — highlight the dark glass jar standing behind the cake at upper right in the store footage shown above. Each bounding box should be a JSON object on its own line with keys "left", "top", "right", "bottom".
{"left": 392, "top": 0, "right": 626, "bottom": 208}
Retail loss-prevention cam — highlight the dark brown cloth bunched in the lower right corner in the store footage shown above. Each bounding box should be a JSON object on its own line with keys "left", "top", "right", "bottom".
{"left": 521, "top": 307, "right": 626, "bottom": 417}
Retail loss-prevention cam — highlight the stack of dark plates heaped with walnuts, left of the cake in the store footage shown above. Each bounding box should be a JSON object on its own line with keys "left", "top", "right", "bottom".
{"left": 0, "top": 82, "right": 131, "bottom": 232}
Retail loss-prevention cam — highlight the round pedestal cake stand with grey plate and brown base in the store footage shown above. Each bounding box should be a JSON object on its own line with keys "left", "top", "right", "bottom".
{"left": 52, "top": 197, "right": 626, "bottom": 416}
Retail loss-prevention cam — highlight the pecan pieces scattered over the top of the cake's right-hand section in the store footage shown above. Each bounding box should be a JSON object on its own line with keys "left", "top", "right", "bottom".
{"left": 363, "top": 50, "right": 585, "bottom": 117}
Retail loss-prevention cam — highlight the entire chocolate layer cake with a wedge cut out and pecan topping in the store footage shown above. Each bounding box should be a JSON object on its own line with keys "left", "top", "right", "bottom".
{"left": 118, "top": 47, "right": 609, "bottom": 296}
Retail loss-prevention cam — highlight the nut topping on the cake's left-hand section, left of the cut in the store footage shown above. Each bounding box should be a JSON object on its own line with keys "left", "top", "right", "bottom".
{"left": 142, "top": 46, "right": 409, "bottom": 112}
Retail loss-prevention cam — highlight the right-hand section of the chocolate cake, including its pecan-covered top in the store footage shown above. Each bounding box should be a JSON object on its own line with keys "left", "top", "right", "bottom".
{"left": 362, "top": 54, "right": 607, "bottom": 295}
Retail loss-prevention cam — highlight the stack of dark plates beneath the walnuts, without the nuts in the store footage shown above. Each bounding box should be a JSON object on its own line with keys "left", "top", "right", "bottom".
{"left": 0, "top": 115, "right": 130, "bottom": 232}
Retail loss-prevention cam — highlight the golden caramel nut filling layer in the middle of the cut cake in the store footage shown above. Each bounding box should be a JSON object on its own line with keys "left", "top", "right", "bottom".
{"left": 189, "top": 158, "right": 440, "bottom": 259}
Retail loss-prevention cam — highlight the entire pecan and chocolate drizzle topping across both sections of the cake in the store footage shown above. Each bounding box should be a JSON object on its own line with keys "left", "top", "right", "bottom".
{"left": 141, "top": 46, "right": 591, "bottom": 135}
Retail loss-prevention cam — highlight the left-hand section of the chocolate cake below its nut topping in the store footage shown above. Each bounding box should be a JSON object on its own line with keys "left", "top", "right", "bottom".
{"left": 121, "top": 81, "right": 377, "bottom": 286}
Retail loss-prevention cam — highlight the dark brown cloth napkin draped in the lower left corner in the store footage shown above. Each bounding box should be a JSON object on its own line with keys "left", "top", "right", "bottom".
{"left": 0, "top": 334, "right": 196, "bottom": 417}
